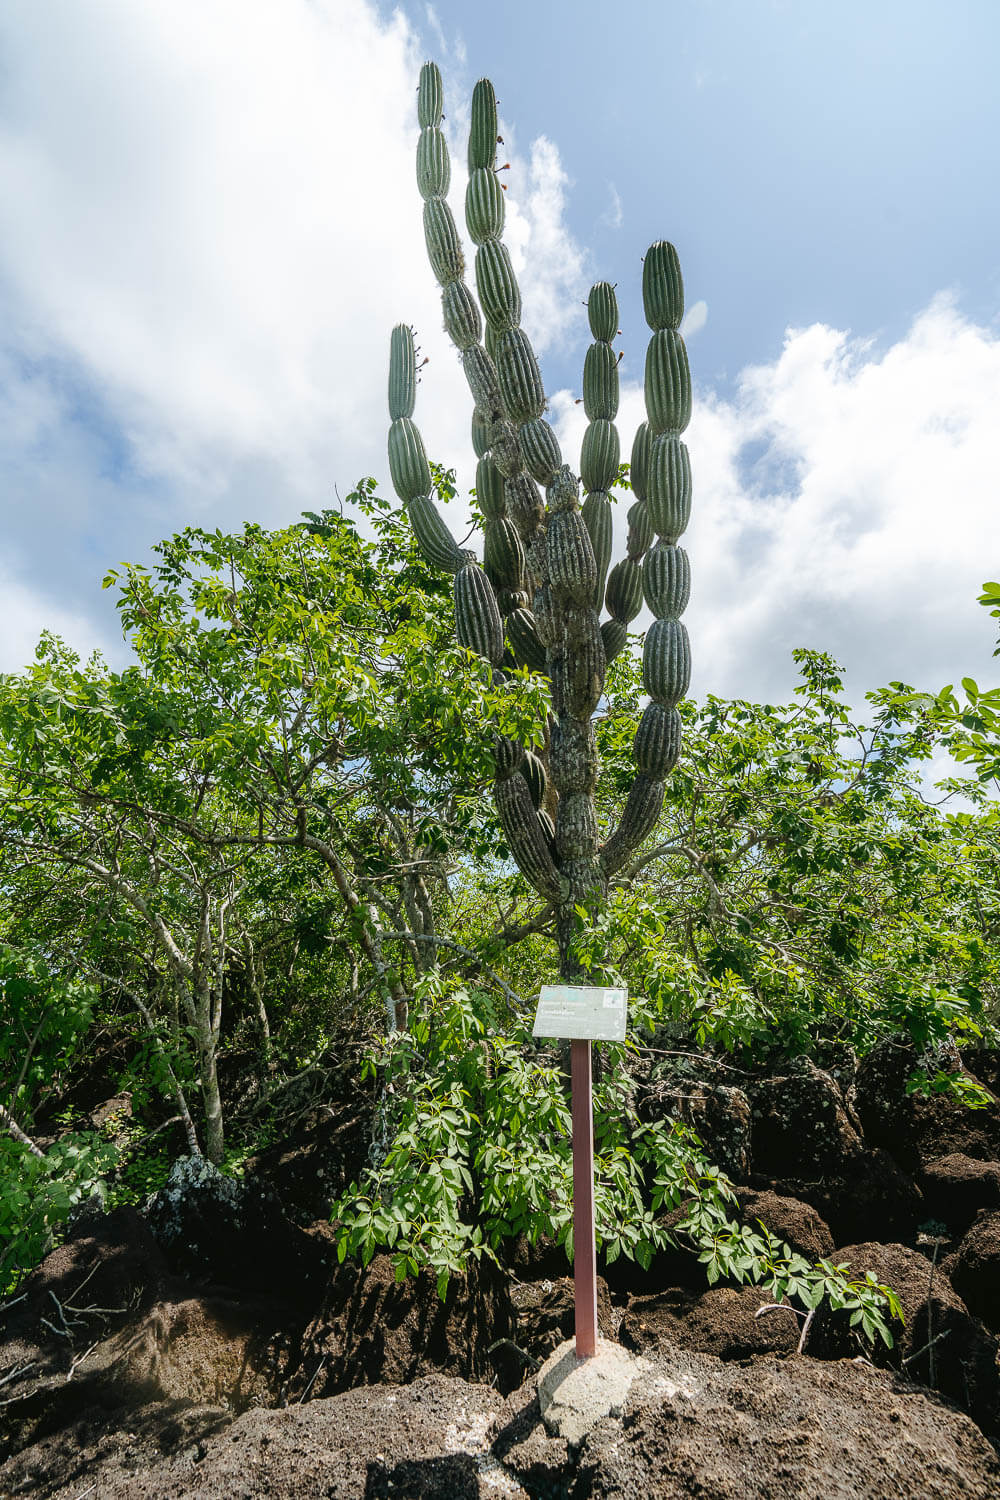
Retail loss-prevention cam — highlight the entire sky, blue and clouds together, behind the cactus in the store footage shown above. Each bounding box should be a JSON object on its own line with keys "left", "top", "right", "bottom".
{"left": 0, "top": 0, "right": 1000, "bottom": 717}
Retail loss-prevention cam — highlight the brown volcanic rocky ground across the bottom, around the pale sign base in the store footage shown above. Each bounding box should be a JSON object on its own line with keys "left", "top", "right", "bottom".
{"left": 0, "top": 1044, "right": 1000, "bottom": 1500}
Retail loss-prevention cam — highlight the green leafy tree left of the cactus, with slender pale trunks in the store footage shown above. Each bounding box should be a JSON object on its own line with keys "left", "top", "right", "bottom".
{"left": 0, "top": 483, "right": 546, "bottom": 1161}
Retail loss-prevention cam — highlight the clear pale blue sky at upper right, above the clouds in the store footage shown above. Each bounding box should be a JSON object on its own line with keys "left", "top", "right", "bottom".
{"left": 406, "top": 0, "right": 1000, "bottom": 386}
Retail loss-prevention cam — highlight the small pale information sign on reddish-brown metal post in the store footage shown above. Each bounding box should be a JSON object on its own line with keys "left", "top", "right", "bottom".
{"left": 532, "top": 984, "right": 628, "bottom": 1359}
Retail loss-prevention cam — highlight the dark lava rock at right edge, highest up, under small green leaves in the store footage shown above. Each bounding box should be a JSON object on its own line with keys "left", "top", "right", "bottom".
{"left": 855, "top": 1038, "right": 1000, "bottom": 1172}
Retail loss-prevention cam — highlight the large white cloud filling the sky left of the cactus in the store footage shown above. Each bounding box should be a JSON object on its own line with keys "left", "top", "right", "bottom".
{"left": 0, "top": 0, "right": 582, "bottom": 669}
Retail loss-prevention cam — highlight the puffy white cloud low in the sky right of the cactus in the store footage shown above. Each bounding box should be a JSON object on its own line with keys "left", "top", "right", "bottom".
{"left": 553, "top": 297, "right": 1000, "bottom": 702}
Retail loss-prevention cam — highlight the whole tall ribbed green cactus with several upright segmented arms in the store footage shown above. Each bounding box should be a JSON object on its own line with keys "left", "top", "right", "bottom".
{"left": 388, "top": 63, "right": 691, "bottom": 978}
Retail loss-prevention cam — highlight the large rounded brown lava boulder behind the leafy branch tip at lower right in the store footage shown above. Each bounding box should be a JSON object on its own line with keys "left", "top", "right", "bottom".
{"left": 808, "top": 1244, "right": 1000, "bottom": 1434}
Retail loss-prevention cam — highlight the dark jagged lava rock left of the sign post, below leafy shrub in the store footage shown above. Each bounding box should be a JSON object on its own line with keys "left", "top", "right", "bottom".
{"left": 284, "top": 1256, "right": 516, "bottom": 1397}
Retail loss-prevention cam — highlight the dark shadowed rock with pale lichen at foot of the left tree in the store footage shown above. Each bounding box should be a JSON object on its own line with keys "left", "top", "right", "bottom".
{"left": 144, "top": 1157, "right": 328, "bottom": 1307}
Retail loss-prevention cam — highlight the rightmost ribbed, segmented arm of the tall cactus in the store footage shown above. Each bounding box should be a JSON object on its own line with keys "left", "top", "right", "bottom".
{"left": 601, "top": 240, "right": 691, "bottom": 879}
